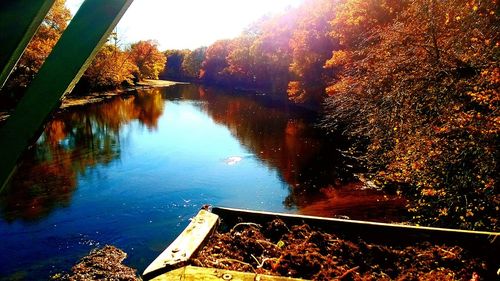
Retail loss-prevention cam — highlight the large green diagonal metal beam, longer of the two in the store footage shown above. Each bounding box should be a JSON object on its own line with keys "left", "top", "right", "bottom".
{"left": 0, "top": 0, "right": 133, "bottom": 191}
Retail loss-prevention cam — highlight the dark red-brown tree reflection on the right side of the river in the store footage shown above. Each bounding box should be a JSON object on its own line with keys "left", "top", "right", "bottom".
{"left": 190, "top": 87, "right": 405, "bottom": 221}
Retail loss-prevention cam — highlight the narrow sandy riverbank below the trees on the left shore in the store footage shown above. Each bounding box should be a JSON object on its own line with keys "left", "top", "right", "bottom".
{"left": 0, "top": 79, "right": 183, "bottom": 124}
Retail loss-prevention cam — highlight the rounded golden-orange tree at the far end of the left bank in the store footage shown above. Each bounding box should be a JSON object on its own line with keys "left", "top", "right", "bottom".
{"left": 129, "top": 40, "right": 166, "bottom": 80}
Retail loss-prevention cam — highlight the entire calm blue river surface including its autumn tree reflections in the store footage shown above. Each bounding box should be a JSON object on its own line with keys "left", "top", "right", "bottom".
{"left": 0, "top": 85, "right": 404, "bottom": 280}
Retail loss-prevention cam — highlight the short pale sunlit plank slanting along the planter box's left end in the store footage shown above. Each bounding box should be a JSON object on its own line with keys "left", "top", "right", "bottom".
{"left": 143, "top": 210, "right": 219, "bottom": 279}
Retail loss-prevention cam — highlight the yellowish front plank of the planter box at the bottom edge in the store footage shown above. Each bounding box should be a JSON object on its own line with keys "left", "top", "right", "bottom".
{"left": 151, "top": 266, "right": 305, "bottom": 281}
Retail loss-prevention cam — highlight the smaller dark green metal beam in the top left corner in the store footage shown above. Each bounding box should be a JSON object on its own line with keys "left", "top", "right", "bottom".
{"left": 0, "top": 0, "right": 55, "bottom": 88}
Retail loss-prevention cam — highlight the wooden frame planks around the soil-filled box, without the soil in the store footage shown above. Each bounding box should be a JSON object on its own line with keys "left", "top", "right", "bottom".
{"left": 144, "top": 207, "right": 500, "bottom": 281}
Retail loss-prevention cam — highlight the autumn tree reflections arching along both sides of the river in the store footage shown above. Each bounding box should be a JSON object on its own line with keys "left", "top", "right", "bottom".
{"left": 0, "top": 85, "right": 404, "bottom": 221}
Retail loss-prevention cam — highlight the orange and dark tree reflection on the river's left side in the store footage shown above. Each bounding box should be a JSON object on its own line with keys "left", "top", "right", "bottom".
{"left": 0, "top": 89, "right": 164, "bottom": 221}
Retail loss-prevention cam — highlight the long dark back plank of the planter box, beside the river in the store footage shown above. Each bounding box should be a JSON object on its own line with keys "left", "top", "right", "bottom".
{"left": 212, "top": 207, "right": 500, "bottom": 258}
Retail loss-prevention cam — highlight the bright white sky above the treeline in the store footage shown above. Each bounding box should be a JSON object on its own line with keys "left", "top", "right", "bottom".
{"left": 66, "top": 0, "right": 304, "bottom": 50}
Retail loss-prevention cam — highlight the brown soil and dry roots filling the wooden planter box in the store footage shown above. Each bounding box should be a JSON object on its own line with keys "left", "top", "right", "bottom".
{"left": 192, "top": 220, "right": 486, "bottom": 281}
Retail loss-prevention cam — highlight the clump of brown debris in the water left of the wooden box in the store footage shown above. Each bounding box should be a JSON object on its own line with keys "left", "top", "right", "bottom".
{"left": 53, "top": 245, "right": 140, "bottom": 281}
